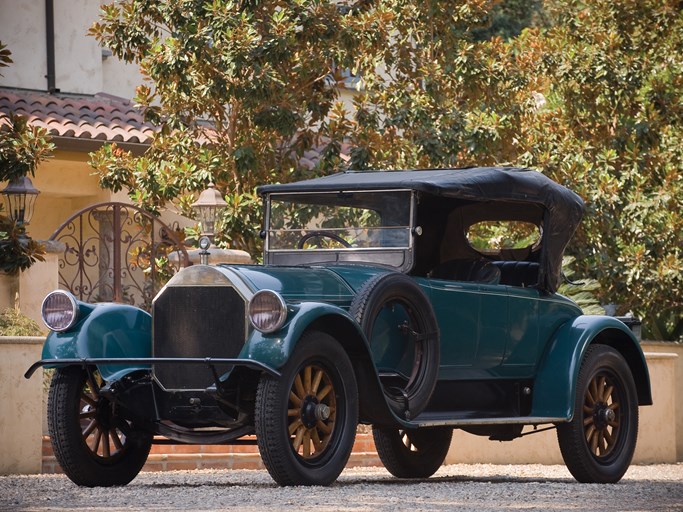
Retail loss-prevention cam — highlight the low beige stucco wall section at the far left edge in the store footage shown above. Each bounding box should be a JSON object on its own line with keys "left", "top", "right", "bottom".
{"left": 0, "top": 337, "right": 45, "bottom": 475}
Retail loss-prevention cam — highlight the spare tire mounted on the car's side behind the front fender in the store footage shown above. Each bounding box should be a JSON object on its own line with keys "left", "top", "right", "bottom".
{"left": 350, "top": 272, "right": 440, "bottom": 420}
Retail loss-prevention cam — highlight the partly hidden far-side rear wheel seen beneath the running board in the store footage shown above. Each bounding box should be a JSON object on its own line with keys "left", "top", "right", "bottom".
{"left": 372, "top": 425, "right": 453, "bottom": 478}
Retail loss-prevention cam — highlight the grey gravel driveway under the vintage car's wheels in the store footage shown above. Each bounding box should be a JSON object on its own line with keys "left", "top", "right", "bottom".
{"left": 0, "top": 464, "right": 683, "bottom": 512}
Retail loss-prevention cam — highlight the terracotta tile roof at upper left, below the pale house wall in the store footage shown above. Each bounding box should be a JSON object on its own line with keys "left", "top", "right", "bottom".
{"left": 0, "top": 88, "right": 155, "bottom": 144}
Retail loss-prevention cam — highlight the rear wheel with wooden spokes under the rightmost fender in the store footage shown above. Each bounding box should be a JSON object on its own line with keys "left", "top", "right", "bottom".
{"left": 557, "top": 345, "right": 638, "bottom": 483}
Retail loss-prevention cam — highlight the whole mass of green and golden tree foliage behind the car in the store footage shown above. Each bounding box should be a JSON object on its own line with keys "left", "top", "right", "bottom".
{"left": 91, "top": 0, "right": 683, "bottom": 338}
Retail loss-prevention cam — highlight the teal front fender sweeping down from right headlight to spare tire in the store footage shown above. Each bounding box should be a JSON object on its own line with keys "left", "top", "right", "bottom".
{"left": 240, "top": 302, "right": 402, "bottom": 424}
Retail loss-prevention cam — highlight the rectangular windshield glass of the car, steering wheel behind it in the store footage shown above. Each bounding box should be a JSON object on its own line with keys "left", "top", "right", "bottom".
{"left": 268, "top": 190, "right": 411, "bottom": 251}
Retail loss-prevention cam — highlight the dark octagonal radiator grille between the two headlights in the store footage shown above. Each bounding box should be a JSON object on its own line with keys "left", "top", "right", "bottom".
{"left": 153, "top": 286, "right": 246, "bottom": 390}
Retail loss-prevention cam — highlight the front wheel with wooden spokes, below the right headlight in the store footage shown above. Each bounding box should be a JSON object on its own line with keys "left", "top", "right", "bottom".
{"left": 255, "top": 331, "right": 358, "bottom": 485}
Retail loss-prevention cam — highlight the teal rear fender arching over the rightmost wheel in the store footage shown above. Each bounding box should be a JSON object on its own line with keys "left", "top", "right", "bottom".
{"left": 532, "top": 315, "right": 652, "bottom": 421}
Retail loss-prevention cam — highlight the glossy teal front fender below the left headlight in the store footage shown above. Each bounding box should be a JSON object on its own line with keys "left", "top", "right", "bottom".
{"left": 42, "top": 303, "right": 152, "bottom": 381}
